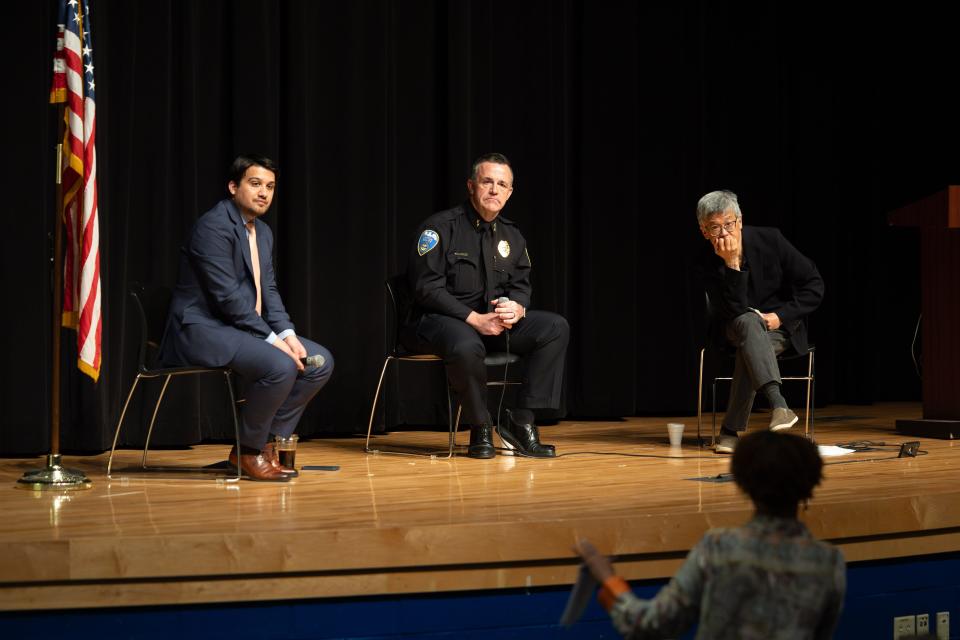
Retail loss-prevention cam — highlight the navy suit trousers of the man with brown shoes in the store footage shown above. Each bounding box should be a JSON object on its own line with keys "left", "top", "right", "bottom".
{"left": 227, "top": 334, "right": 333, "bottom": 449}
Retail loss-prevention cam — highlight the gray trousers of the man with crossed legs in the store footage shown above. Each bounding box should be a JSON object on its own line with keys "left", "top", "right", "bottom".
{"left": 723, "top": 311, "right": 790, "bottom": 431}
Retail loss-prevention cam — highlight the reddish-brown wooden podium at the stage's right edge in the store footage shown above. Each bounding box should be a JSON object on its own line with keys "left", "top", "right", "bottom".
{"left": 887, "top": 186, "right": 960, "bottom": 439}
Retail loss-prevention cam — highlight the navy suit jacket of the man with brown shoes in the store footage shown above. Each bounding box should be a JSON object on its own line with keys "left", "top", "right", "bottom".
{"left": 160, "top": 200, "right": 294, "bottom": 367}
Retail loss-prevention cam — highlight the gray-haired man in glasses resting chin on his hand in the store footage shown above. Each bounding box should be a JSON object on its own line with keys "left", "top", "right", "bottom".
{"left": 697, "top": 191, "right": 823, "bottom": 453}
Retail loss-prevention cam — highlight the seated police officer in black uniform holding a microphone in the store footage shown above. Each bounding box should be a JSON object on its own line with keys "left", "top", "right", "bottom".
{"left": 403, "top": 153, "right": 570, "bottom": 458}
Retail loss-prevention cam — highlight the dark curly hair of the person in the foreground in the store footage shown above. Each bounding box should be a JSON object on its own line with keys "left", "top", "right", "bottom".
{"left": 730, "top": 431, "right": 823, "bottom": 512}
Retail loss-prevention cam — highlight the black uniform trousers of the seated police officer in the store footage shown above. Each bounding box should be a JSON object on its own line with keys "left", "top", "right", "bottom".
{"left": 404, "top": 310, "right": 570, "bottom": 425}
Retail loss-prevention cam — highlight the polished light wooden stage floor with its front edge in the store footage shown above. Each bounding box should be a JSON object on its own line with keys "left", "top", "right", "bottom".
{"left": 0, "top": 404, "right": 960, "bottom": 610}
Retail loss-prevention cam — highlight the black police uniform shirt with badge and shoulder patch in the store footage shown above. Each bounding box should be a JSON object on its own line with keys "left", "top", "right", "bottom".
{"left": 408, "top": 202, "right": 531, "bottom": 320}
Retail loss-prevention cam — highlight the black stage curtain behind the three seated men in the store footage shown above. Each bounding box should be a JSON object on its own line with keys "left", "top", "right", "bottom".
{"left": 0, "top": 0, "right": 960, "bottom": 455}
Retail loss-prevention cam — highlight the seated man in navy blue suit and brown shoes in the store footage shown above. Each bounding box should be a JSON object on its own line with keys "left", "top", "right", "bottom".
{"left": 160, "top": 155, "right": 333, "bottom": 482}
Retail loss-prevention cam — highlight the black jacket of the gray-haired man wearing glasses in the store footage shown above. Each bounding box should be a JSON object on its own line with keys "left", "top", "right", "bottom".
{"left": 698, "top": 226, "right": 824, "bottom": 353}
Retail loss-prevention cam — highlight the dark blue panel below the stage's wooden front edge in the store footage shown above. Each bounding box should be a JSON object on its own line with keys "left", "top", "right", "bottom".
{"left": 0, "top": 553, "right": 960, "bottom": 640}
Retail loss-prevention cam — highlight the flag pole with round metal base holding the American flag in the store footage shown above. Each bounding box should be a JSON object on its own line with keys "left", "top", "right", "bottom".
{"left": 17, "top": 104, "right": 93, "bottom": 491}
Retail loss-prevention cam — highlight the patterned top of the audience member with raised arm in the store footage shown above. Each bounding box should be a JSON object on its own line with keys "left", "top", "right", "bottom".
{"left": 610, "top": 515, "right": 846, "bottom": 640}
